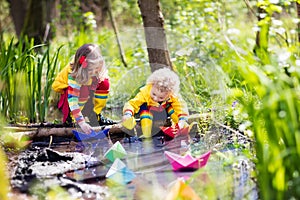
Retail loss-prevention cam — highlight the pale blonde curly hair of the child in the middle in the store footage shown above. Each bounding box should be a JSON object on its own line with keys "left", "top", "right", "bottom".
{"left": 146, "top": 68, "right": 180, "bottom": 94}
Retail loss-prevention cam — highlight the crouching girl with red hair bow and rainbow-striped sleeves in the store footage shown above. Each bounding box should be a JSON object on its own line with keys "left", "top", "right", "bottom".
{"left": 52, "top": 44, "right": 114, "bottom": 134}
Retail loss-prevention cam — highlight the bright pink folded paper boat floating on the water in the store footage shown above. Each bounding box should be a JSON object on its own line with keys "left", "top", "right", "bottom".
{"left": 165, "top": 151, "right": 210, "bottom": 171}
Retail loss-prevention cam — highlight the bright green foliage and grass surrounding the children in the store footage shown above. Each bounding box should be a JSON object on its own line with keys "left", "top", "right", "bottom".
{"left": 0, "top": 0, "right": 300, "bottom": 199}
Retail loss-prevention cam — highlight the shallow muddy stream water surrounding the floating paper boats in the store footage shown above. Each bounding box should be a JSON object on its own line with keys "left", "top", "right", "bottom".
{"left": 11, "top": 127, "right": 258, "bottom": 199}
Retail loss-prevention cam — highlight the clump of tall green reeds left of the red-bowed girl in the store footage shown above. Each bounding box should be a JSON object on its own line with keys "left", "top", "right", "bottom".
{"left": 0, "top": 38, "right": 62, "bottom": 123}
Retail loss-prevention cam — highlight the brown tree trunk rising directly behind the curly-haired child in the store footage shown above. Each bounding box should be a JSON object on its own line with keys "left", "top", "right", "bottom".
{"left": 138, "top": 0, "right": 172, "bottom": 72}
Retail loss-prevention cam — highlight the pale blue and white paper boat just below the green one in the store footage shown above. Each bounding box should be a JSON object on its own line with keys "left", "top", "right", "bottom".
{"left": 105, "top": 158, "right": 136, "bottom": 185}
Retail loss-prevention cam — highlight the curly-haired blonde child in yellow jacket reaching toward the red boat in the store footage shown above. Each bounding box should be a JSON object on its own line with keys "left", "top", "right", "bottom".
{"left": 122, "top": 68, "right": 188, "bottom": 137}
